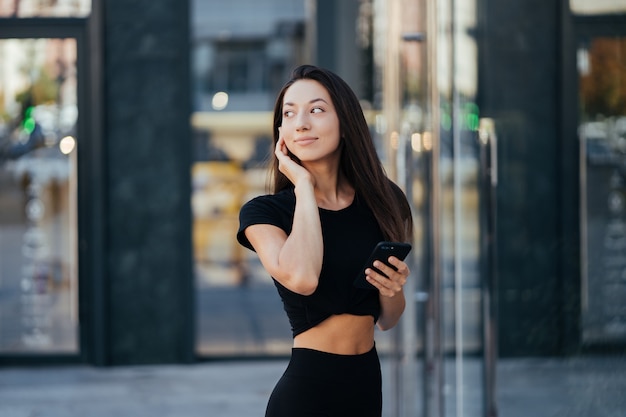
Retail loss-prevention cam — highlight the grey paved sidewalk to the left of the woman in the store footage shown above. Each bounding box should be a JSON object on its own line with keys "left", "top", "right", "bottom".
{"left": 0, "top": 361, "right": 286, "bottom": 417}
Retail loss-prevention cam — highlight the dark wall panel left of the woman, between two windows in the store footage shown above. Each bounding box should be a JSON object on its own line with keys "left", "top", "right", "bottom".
{"left": 103, "top": 0, "right": 193, "bottom": 365}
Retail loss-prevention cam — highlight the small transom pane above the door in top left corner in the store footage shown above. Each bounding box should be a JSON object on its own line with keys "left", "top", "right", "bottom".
{"left": 0, "top": 0, "right": 91, "bottom": 17}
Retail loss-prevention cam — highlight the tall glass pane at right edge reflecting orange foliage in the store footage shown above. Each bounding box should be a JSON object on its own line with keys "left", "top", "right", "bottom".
{"left": 577, "top": 34, "right": 626, "bottom": 346}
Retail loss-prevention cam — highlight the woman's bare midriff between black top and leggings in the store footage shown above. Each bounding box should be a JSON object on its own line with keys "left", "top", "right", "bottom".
{"left": 293, "top": 314, "right": 374, "bottom": 355}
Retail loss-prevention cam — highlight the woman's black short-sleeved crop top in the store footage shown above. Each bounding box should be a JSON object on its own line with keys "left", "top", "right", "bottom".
{"left": 237, "top": 188, "right": 383, "bottom": 337}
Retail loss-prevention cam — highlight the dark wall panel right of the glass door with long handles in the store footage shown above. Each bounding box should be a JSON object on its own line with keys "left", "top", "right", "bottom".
{"left": 480, "top": 0, "right": 562, "bottom": 356}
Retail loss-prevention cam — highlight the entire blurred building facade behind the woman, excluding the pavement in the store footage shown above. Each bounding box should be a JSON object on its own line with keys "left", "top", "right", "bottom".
{"left": 0, "top": 0, "right": 626, "bottom": 416}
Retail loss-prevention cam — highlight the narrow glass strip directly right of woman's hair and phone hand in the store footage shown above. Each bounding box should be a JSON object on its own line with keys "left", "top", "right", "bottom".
{"left": 373, "top": 0, "right": 428, "bottom": 417}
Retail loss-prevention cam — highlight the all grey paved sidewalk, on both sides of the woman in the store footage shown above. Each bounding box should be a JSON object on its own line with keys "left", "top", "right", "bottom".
{"left": 0, "top": 357, "right": 626, "bottom": 417}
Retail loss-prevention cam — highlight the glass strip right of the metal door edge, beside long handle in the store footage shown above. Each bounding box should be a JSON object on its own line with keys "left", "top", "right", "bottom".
{"left": 427, "top": 0, "right": 487, "bottom": 416}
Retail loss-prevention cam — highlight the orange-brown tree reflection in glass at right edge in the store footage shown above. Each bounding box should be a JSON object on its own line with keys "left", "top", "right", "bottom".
{"left": 580, "top": 38, "right": 626, "bottom": 118}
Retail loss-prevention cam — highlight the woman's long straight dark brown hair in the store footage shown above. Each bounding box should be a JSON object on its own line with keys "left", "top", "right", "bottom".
{"left": 271, "top": 65, "right": 413, "bottom": 241}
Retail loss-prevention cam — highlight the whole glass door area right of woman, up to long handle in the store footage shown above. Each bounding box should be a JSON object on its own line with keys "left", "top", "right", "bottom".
{"left": 374, "top": 0, "right": 495, "bottom": 417}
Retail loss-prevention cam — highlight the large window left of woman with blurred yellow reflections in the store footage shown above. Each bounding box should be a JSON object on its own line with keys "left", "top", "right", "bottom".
{"left": 191, "top": 0, "right": 306, "bottom": 356}
